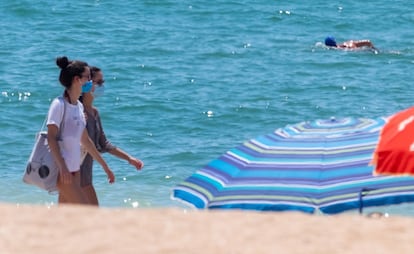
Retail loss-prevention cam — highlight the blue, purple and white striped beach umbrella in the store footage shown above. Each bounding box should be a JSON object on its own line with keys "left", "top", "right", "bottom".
{"left": 172, "top": 117, "right": 414, "bottom": 214}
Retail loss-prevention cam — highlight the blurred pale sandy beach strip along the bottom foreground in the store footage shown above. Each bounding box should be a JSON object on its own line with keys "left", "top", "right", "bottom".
{"left": 0, "top": 204, "right": 414, "bottom": 254}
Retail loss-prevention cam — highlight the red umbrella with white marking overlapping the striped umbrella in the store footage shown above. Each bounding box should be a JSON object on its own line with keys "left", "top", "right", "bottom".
{"left": 372, "top": 107, "right": 414, "bottom": 175}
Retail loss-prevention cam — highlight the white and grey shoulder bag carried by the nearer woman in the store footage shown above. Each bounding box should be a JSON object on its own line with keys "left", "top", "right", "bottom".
{"left": 23, "top": 97, "right": 65, "bottom": 193}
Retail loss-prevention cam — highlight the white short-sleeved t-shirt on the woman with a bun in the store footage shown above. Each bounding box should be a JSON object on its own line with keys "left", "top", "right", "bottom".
{"left": 47, "top": 97, "right": 86, "bottom": 172}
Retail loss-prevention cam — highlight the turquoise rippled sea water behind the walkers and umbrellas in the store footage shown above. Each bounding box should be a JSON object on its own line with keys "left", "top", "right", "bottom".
{"left": 0, "top": 0, "right": 414, "bottom": 216}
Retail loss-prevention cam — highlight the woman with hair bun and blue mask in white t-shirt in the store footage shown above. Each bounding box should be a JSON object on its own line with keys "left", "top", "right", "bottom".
{"left": 47, "top": 56, "right": 115, "bottom": 204}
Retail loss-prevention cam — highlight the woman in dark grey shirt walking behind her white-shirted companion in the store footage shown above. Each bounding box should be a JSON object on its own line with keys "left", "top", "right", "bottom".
{"left": 80, "top": 66, "right": 144, "bottom": 205}
